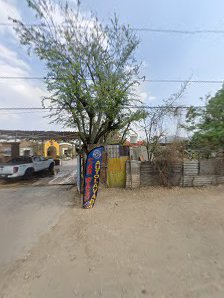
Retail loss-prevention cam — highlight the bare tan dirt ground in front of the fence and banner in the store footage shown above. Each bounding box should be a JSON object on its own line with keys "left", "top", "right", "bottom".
{"left": 0, "top": 186, "right": 224, "bottom": 298}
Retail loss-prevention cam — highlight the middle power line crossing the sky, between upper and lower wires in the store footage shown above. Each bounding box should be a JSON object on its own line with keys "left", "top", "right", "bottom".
{"left": 0, "top": 76, "right": 224, "bottom": 84}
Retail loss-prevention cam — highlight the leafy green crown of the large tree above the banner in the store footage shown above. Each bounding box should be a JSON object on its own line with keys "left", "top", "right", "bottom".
{"left": 11, "top": 0, "right": 142, "bottom": 147}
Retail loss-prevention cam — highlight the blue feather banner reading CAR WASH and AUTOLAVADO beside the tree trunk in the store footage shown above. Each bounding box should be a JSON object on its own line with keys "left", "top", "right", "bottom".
{"left": 83, "top": 146, "right": 104, "bottom": 209}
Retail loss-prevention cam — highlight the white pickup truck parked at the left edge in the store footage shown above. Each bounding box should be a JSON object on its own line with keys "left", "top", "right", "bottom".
{"left": 0, "top": 156, "right": 55, "bottom": 179}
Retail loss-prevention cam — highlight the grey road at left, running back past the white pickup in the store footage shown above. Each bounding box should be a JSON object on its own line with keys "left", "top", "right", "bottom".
{"left": 0, "top": 159, "right": 76, "bottom": 267}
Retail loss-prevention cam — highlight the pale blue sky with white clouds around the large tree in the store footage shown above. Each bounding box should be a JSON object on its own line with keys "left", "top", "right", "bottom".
{"left": 0, "top": 0, "right": 224, "bottom": 130}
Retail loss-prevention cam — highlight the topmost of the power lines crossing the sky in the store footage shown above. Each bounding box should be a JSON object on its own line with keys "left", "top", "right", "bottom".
{"left": 0, "top": 22, "right": 224, "bottom": 35}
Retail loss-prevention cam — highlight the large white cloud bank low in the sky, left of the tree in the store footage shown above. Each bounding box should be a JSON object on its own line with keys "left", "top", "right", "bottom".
{"left": 0, "top": 44, "right": 53, "bottom": 129}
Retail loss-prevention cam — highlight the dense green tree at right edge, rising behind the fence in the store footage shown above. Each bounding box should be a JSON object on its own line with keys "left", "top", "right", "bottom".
{"left": 186, "top": 87, "right": 224, "bottom": 150}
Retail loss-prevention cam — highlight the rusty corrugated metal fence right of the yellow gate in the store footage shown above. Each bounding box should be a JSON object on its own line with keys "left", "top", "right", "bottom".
{"left": 126, "top": 159, "right": 224, "bottom": 188}
